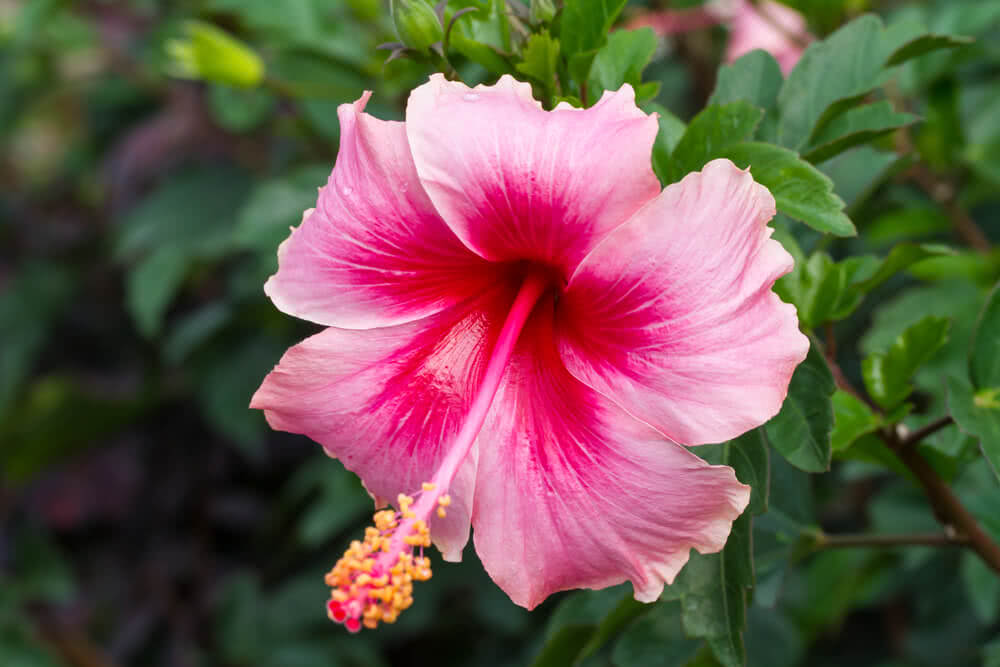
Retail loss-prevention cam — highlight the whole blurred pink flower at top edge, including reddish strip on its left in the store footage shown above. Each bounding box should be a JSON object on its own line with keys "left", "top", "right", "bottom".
{"left": 625, "top": 0, "right": 813, "bottom": 75}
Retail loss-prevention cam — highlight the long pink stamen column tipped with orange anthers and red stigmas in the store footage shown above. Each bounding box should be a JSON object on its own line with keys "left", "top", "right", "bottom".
{"left": 326, "top": 272, "right": 551, "bottom": 632}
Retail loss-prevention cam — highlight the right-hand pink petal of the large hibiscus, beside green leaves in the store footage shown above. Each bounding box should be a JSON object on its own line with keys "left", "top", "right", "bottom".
{"left": 560, "top": 160, "right": 809, "bottom": 445}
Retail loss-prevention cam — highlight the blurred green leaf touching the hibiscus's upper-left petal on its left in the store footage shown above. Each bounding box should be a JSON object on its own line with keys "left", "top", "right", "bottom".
{"left": 234, "top": 165, "right": 330, "bottom": 253}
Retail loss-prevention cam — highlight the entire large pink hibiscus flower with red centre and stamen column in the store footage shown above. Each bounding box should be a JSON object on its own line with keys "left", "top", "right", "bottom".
{"left": 251, "top": 75, "right": 808, "bottom": 631}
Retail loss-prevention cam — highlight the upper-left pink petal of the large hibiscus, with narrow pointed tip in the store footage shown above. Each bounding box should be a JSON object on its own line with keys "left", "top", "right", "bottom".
{"left": 264, "top": 93, "right": 496, "bottom": 328}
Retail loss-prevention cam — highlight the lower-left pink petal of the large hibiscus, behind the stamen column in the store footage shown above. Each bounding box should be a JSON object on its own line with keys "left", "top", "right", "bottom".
{"left": 250, "top": 284, "right": 516, "bottom": 560}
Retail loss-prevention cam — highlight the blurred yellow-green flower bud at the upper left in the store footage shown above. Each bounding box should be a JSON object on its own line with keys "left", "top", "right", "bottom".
{"left": 166, "top": 21, "right": 264, "bottom": 88}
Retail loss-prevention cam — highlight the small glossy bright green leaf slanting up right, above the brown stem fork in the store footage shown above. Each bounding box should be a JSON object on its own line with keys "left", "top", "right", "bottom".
{"left": 861, "top": 316, "right": 951, "bottom": 410}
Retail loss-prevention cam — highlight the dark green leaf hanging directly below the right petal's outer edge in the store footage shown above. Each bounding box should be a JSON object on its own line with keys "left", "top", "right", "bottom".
{"left": 764, "top": 345, "right": 836, "bottom": 472}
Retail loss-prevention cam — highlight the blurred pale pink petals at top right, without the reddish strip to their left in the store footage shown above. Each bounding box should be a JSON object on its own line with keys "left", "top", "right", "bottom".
{"left": 726, "top": 0, "right": 812, "bottom": 75}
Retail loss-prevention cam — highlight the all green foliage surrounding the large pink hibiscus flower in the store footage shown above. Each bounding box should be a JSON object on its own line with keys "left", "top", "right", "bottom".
{"left": 0, "top": 0, "right": 1000, "bottom": 667}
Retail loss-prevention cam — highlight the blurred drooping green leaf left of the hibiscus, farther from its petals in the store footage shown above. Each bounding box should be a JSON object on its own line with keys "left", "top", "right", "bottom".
{"left": 125, "top": 246, "right": 190, "bottom": 338}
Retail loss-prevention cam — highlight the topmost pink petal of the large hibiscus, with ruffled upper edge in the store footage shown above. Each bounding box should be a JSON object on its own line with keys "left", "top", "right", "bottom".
{"left": 406, "top": 74, "right": 659, "bottom": 277}
